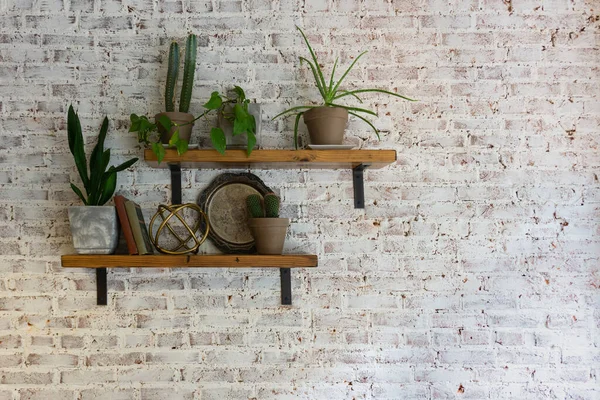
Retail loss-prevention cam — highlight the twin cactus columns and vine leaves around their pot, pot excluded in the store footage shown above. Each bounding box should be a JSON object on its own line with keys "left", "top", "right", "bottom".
{"left": 129, "top": 35, "right": 200, "bottom": 163}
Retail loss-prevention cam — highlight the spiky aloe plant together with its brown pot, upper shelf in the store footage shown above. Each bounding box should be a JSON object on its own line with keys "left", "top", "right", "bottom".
{"left": 273, "top": 27, "right": 415, "bottom": 149}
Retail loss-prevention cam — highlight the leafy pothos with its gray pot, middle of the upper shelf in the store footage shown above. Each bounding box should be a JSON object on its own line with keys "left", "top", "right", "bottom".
{"left": 204, "top": 86, "right": 260, "bottom": 155}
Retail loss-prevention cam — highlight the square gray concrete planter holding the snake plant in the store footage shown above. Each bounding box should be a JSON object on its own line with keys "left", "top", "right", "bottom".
{"left": 69, "top": 206, "right": 119, "bottom": 254}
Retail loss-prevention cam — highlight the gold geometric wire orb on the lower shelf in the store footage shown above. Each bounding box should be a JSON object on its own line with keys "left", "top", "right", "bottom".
{"left": 149, "top": 203, "right": 210, "bottom": 254}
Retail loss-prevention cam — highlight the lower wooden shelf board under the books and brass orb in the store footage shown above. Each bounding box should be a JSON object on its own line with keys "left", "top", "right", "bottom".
{"left": 61, "top": 254, "right": 318, "bottom": 268}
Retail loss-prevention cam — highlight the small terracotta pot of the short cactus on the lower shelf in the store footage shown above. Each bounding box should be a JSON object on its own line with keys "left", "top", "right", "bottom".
{"left": 248, "top": 218, "right": 290, "bottom": 254}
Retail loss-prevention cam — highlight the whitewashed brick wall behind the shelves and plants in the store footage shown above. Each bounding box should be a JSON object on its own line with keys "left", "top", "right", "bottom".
{"left": 0, "top": 0, "right": 600, "bottom": 400}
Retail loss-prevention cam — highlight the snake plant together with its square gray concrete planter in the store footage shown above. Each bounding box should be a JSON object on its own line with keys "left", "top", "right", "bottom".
{"left": 67, "top": 106, "right": 138, "bottom": 254}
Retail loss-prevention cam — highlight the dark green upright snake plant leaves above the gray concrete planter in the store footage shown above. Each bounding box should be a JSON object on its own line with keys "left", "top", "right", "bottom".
{"left": 67, "top": 105, "right": 138, "bottom": 206}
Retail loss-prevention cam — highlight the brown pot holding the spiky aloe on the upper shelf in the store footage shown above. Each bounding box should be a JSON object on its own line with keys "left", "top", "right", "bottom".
{"left": 304, "top": 107, "right": 348, "bottom": 144}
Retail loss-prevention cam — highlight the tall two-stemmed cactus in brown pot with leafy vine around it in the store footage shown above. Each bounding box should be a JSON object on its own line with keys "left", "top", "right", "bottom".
{"left": 129, "top": 34, "right": 200, "bottom": 162}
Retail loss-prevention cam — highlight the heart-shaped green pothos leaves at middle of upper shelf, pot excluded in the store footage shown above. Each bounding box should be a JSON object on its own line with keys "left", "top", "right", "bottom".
{"left": 204, "top": 86, "right": 256, "bottom": 155}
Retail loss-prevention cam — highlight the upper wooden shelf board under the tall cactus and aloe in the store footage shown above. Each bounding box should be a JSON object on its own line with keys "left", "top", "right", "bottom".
{"left": 144, "top": 149, "right": 396, "bottom": 169}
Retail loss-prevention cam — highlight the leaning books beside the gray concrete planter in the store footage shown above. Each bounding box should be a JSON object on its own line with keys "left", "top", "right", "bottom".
{"left": 115, "top": 195, "right": 154, "bottom": 255}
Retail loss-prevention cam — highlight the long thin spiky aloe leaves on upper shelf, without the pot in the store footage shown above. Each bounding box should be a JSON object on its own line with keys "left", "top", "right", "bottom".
{"left": 273, "top": 26, "right": 416, "bottom": 149}
